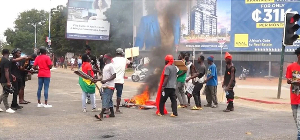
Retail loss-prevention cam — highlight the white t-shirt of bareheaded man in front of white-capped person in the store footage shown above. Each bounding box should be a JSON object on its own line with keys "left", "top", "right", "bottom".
{"left": 102, "top": 63, "right": 116, "bottom": 87}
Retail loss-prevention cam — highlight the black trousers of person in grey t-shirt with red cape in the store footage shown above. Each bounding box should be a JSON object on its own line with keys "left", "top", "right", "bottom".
{"left": 159, "top": 88, "right": 178, "bottom": 116}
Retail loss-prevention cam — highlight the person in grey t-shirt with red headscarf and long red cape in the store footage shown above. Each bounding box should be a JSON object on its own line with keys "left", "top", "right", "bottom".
{"left": 156, "top": 55, "right": 178, "bottom": 117}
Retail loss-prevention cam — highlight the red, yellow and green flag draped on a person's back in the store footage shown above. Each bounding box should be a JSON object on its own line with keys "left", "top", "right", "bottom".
{"left": 79, "top": 63, "right": 96, "bottom": 94}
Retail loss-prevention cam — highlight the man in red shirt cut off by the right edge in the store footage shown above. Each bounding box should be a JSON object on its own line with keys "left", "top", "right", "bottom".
{"left": 286, "top": 47, "right": 300, "bottom": 140}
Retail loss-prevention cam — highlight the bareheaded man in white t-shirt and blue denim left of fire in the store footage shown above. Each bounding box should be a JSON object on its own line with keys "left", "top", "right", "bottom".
{"left": 95, "top": 54, "right": 116, "bottom": 120}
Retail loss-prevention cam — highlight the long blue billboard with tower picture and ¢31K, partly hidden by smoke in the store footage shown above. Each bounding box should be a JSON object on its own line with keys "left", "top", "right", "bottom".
{"left": 135, "top": 0, "right": 300, "bottom": 52}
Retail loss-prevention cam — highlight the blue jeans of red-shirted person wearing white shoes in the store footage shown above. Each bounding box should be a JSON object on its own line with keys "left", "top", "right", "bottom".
{"left": 37, "top": 77, "right": 50, "bottom": 100}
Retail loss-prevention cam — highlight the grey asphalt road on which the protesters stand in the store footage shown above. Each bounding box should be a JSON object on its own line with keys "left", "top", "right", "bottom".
{"left": 0, "top": 72, "right": 296, "bottom": 140}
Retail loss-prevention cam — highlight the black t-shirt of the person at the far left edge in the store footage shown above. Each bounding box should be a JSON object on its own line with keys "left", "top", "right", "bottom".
{"left": 0, "top": 57, "right": 12, "bottom": 83}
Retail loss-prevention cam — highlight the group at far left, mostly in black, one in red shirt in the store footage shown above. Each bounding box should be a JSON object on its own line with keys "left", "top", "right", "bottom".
{"left": 0, "top": 47, "right": 52, "bottom": 113}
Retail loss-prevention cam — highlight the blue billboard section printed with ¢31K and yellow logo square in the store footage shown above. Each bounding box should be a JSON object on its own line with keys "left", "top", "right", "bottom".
{"left": 229, "top": 0, "right": 300, "bottom": 52}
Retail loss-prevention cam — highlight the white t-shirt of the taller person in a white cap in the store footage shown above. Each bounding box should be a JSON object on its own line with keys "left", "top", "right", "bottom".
{"left": 113, "top": 57, "right": 127, "bottom": 84}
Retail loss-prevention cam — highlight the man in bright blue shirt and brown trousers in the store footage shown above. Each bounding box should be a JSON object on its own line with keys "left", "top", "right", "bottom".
{"left": 204, "top": 56, "right": 218, "bottom": 108}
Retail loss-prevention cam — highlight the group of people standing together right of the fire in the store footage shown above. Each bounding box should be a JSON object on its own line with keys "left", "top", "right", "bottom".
{"left": 156, "top": 52, "right": 236, "bottom": 117}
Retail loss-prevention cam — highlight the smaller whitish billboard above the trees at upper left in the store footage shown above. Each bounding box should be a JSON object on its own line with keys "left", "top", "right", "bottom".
{"left": 66, "top": 0, "right": 111, "bottom": 40}
